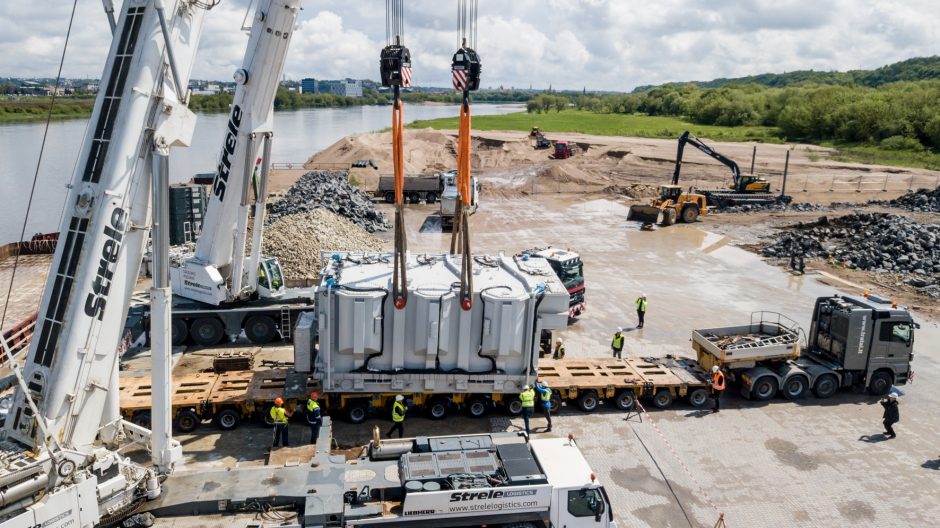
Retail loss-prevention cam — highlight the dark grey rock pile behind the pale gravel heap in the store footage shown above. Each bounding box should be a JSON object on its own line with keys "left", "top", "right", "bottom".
{"left": 267, "top": 171, "right": 391, "bottom": 233}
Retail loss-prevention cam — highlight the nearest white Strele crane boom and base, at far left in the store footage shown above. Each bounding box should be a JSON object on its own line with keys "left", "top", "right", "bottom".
{"left": 0, "top": 0, "right": 215, "bottom": 527}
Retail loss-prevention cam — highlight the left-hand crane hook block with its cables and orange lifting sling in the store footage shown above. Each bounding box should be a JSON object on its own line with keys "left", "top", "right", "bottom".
{"left": 380, "top": 0, "right": 411, "bottom": 310}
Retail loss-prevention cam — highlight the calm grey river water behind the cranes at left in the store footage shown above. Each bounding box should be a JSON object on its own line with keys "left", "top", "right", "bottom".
{"left": 0, "top": 104, "right": 523, "bottom": 244}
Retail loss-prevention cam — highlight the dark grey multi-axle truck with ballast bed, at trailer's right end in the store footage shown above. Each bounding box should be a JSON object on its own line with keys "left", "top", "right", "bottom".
{"left": 692, "top": 295, "right": 918, "bottom": 400}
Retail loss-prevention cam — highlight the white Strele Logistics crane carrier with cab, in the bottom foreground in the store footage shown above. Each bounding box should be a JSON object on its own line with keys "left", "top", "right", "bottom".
{"left": 147, "top": 426, "right": 617, "bottom": 528}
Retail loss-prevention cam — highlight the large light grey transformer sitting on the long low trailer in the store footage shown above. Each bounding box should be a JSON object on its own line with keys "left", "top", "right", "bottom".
{"left": 314, "top": 253, "right": 568, "bottom": 393}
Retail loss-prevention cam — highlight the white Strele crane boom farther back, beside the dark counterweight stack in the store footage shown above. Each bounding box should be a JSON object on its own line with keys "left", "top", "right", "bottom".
{"left": 170, "top": 0, "right": 300, "bottom": 305}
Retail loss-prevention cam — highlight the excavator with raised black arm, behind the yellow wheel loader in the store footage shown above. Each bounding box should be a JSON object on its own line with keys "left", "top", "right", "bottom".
{"left": 672, "top": 130, "right": 789, "bottom": 207}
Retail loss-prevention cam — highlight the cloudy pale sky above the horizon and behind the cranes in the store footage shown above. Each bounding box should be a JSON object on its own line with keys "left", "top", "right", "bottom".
{"left": 0, "top": 0, "right": 940, "bottom": 91}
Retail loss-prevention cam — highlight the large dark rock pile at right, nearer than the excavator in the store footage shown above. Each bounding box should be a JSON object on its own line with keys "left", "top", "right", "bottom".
{"left": 762, "top": 213, "right": 940, "bottom": 276}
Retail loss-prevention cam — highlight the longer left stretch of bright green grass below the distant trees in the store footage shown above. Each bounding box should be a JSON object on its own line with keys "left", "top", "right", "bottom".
{"left": 408, "top": 110, "right": 783, "bottom": 143}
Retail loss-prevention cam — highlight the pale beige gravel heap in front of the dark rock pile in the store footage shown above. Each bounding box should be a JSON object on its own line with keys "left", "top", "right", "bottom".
{"left": 262, "top": 209, "right": 382, "bottom": 279}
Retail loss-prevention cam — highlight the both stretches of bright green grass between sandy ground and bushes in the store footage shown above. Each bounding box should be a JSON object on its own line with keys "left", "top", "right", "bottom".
{"left": 408, "top": 110, "right": 940, "bottom": 170}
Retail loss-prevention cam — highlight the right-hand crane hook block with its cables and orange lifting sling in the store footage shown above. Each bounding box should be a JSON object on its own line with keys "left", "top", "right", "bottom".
{"left": 450, "top": 0, "right": 480, "bottom": 311}
